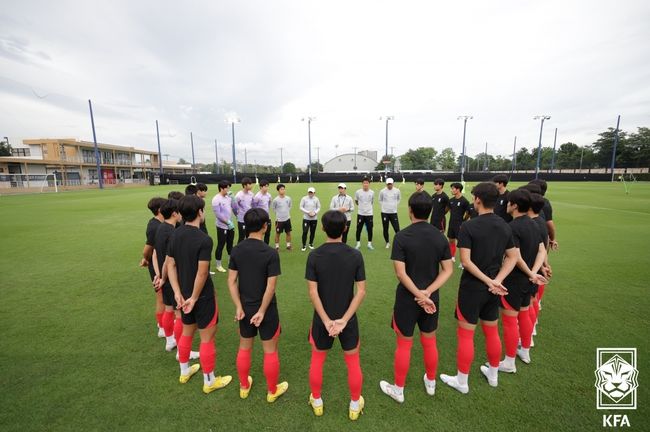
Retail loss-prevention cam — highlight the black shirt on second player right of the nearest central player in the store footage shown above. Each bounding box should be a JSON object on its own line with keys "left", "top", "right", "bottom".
{"left": 458, "top": 213, "right": 514, "bottom": 289}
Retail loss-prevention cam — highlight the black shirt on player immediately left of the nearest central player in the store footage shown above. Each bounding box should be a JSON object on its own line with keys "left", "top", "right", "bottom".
{"left": 228, "top": 237, "right": 280, "bottom": 306}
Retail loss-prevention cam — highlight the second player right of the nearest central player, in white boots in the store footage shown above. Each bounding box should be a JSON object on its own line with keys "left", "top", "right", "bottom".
{"left": 440, "top": 182, "right": 519, "bottom": 394}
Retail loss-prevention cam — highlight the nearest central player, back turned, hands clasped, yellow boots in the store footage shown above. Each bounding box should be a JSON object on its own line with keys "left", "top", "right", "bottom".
{"left": 305, "top": 210, "right": 366, "bottom": 420}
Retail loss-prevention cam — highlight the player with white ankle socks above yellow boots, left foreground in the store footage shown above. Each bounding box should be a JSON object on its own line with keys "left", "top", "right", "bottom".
{"left": 167, "top": 195, "right": 232, "bottom": 394}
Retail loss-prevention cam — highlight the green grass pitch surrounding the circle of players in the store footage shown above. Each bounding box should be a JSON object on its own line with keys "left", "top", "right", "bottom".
{"left": 0, "top": 183, "right": 650, "bottom": 431}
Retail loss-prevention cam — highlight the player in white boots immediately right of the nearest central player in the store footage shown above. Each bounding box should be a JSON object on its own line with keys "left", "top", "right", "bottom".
{"left": 379, "top": 191, "right": 453, "bottom": 403}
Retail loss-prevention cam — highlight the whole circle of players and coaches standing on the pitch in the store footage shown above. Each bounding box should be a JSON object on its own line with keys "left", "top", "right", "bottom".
{"left": 141, "top": 175, "right": 557, "bottom": 420}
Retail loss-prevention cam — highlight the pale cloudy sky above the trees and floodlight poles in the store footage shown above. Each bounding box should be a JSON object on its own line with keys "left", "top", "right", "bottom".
{"left": 0, "top": 0, "right": 650, "bottom": 165}
